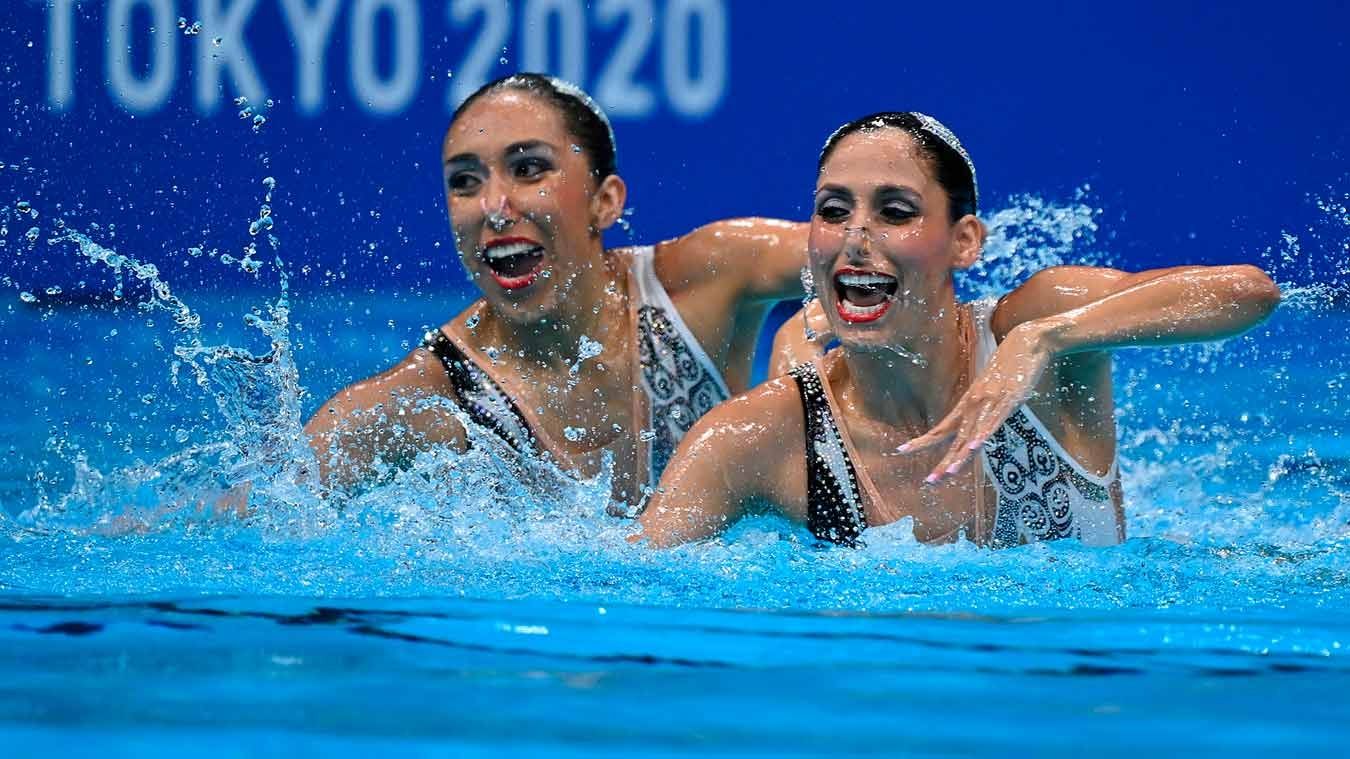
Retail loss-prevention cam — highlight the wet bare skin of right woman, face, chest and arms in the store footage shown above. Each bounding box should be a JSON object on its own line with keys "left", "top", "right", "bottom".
{"left": 635, "top": 128, "right": 1280, "bottom": 546}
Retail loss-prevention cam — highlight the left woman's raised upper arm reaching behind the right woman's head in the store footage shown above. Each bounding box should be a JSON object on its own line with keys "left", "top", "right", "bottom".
{"left": 660, "top": 217, "right": 807, "bottom": 301}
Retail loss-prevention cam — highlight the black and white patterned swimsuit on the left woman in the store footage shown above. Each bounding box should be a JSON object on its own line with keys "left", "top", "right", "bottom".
{"left": 423, "top": 246, "right": 730, "bottom": 488}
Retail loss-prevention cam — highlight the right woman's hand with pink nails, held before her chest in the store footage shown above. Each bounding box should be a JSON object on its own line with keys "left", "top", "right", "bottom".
{"left": 898, "top": 323, "right": 1056, "bottom": 485}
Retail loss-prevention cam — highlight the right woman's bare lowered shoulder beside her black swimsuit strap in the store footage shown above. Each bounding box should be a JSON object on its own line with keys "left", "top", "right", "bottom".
{"left": 636, "top": 377, "right": 806, "bottom": 547}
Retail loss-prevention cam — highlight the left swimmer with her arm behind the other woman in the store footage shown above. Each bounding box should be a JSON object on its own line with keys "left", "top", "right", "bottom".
{"left": 305, "top": 74, "right": 807, "bottom": 506}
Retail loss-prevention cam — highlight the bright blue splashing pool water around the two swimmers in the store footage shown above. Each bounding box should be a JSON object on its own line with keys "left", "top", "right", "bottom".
{"left": 0, "top": 199, "right": 1350, "bottom": 756}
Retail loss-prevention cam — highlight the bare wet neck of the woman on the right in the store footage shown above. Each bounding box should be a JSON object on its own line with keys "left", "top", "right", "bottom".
{"left": 840, "top": 289, "right": 975, "bottom": 435}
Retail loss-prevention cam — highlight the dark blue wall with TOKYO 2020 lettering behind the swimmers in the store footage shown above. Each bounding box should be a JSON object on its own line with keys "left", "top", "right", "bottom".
{"left": 0, "top": 0, "right": 1350, "bottom": 293}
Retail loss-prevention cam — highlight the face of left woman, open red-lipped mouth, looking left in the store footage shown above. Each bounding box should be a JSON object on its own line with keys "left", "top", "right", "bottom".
{"left": 441, "top": 90, "right": 624, "bottom": 324}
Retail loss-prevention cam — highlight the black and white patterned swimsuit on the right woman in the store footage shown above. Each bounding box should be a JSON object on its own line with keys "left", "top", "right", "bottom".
{"left": 791, "top": 298, "right": 1121, "bottom": 547}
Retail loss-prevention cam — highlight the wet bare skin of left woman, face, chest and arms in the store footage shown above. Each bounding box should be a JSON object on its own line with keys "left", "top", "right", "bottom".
{"left": 306, "top": 90, "right": 806, "bottom": 502}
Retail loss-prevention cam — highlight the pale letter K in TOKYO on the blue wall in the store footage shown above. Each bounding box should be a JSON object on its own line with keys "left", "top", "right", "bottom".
{"left": 195, "top": 0, "right": 266, "bottom": 113}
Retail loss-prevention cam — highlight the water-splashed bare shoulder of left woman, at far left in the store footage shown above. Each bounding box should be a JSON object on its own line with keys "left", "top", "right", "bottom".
{"left": 305, "top": 329, "right": 466, "bottom": 486}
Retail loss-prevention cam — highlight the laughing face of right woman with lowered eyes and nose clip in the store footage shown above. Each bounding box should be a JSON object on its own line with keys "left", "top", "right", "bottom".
{"left": 810, "top": 128, "right": 983, "bottom": 350}
